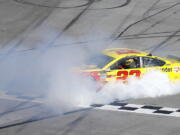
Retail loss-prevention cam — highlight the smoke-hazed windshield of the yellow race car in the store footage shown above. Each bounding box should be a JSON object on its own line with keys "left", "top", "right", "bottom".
{"left": 85, "top": 55, "right": 114, "bottom": 68}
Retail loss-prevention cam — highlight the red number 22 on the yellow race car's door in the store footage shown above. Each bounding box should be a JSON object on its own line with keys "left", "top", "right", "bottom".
{"left": 117, "top": 70, "right": 141, "bottom": 80}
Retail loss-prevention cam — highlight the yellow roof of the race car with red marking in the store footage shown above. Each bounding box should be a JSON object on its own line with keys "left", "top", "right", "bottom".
{"left": 103, "top": 48, "right": 148, "bottom": 58}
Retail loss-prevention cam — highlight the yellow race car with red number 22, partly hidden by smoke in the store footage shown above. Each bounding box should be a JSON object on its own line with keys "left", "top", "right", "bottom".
{"left": 81, "top": 48, "right": 180, "bottom": 83}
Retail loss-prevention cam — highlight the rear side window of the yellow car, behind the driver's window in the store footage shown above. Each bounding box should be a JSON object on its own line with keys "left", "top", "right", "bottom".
{"left": 142, "top": 57, "right": 165, "bottom": 67}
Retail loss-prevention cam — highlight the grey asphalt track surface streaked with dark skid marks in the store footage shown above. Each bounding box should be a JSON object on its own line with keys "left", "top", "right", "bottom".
{"left": 0, "top": 0, "right": 180, "bottom": 135}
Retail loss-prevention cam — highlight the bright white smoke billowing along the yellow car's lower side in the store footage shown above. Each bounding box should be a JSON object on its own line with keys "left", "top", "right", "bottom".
{"left": 96, "top": 71, "right": 180, "bottom": 104}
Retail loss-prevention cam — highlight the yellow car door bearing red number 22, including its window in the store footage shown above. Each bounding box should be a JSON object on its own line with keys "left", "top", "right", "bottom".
{"left": 106, "top": 56, "right": 142, "bottom": 81}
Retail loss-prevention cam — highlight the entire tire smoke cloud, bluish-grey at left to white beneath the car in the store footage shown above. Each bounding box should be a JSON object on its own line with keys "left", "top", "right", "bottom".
{"left": 0, "top": 32, "right": 180, "bottom": 112}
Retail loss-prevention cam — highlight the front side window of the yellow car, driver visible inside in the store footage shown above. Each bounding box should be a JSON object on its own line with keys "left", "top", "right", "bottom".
{"left": 111, "top": 57, "right": 140, "bottom": 70}
